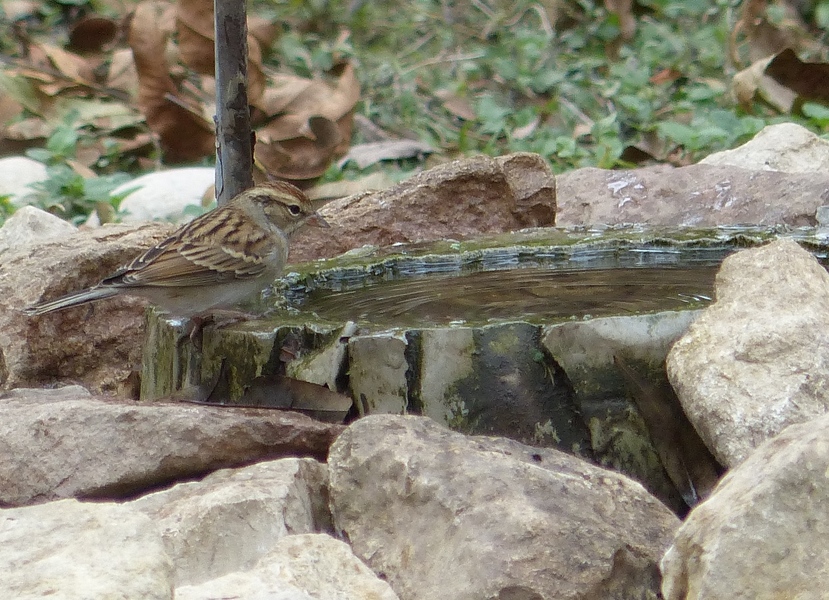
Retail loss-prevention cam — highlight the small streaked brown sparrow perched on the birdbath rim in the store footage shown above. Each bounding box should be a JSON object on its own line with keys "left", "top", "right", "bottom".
{"left": 23, "top": 181, "right": 328, "bottom": 318}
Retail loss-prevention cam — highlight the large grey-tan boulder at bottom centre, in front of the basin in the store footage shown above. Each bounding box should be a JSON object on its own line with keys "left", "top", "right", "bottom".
{"left": 329, "top": 415, "right": 679, "bottom": 600}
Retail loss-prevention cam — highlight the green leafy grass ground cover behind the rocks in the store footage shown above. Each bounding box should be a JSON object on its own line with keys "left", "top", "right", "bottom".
{"left": 0, "top": 0, "right": 829, "bottom": 220}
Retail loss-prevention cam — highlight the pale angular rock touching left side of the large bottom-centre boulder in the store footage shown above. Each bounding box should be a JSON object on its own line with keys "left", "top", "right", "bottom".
{"left": 131, "top": 458, "right": 332, "bottom": 586}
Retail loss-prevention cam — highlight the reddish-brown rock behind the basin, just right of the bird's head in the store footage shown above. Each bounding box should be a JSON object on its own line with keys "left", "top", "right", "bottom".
{"left": 291, "top": 153, "right": 556, "bottom": 261}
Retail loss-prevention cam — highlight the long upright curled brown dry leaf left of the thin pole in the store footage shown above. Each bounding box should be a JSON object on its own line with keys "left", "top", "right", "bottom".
{"left": 129, "top": 0, "right": 215, "bottom": 162}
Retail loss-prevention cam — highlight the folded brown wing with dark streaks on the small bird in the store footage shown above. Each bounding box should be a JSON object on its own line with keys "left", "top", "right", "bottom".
{"left": 104, "top": 205, "right": 270, "bottom": 287}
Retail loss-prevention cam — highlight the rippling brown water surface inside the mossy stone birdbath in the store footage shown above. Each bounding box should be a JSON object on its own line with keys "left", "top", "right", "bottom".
{"left": 294, "top": 264, "right": 718, "bottom": 326}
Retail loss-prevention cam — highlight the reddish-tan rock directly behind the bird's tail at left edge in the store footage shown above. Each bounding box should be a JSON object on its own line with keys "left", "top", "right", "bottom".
{"left": 0, "top": 223, "right": 172, "bottom": 396}
